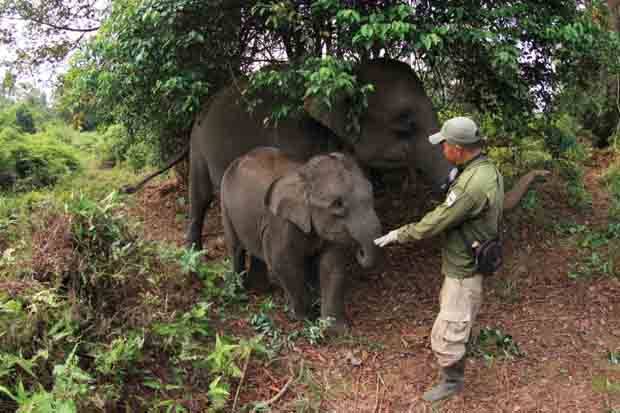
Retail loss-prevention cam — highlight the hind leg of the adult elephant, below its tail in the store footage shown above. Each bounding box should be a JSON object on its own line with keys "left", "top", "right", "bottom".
{"left": 187, "top": 157, "right": 213, "bottom": 250}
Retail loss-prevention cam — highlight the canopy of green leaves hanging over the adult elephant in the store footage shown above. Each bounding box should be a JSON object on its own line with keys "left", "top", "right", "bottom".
{"left": 57, "top": 0, "right": 620, "bottom": 158}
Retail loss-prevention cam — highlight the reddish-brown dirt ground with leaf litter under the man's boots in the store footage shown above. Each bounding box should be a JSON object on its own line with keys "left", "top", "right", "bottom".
{"left": 135, "top": 153, "right": 620, "bottom": 413}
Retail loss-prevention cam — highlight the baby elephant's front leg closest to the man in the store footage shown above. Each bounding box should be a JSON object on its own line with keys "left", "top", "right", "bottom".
{"left": 319, "top": 247, "right": 348, "bottom": 333}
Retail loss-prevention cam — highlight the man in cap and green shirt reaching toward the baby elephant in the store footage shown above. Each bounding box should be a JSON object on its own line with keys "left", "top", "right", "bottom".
{"left": 375, "top": 117, "right": 504, "bottom": 402}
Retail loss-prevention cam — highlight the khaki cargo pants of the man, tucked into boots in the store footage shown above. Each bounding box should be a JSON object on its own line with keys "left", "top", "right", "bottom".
{"left": 431, "top": 275, "right": 482, "bottom": 367}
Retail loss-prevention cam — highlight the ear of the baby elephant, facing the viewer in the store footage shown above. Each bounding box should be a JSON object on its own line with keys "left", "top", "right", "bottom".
{"left": 265, "top": 172, "right": 312, "bottom": 234}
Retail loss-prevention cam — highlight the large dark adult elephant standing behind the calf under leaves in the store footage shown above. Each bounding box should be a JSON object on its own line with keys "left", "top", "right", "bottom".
{"left": 125, "top": 59, "right": 453, "bottom": 248}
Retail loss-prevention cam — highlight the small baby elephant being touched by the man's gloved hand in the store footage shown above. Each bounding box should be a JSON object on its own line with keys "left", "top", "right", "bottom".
{"left": 220, "top": 147, "right": 381, "bottom": 332}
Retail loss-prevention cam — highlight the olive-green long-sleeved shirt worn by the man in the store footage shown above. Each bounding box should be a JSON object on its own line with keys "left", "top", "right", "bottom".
{"left": 398, "top": 157, "right": 504, "bottom": 278}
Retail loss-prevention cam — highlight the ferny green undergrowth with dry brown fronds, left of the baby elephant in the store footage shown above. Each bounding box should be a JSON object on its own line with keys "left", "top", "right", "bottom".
{"left": 0, "top": 193, "right": 267, "bottom": 412}
